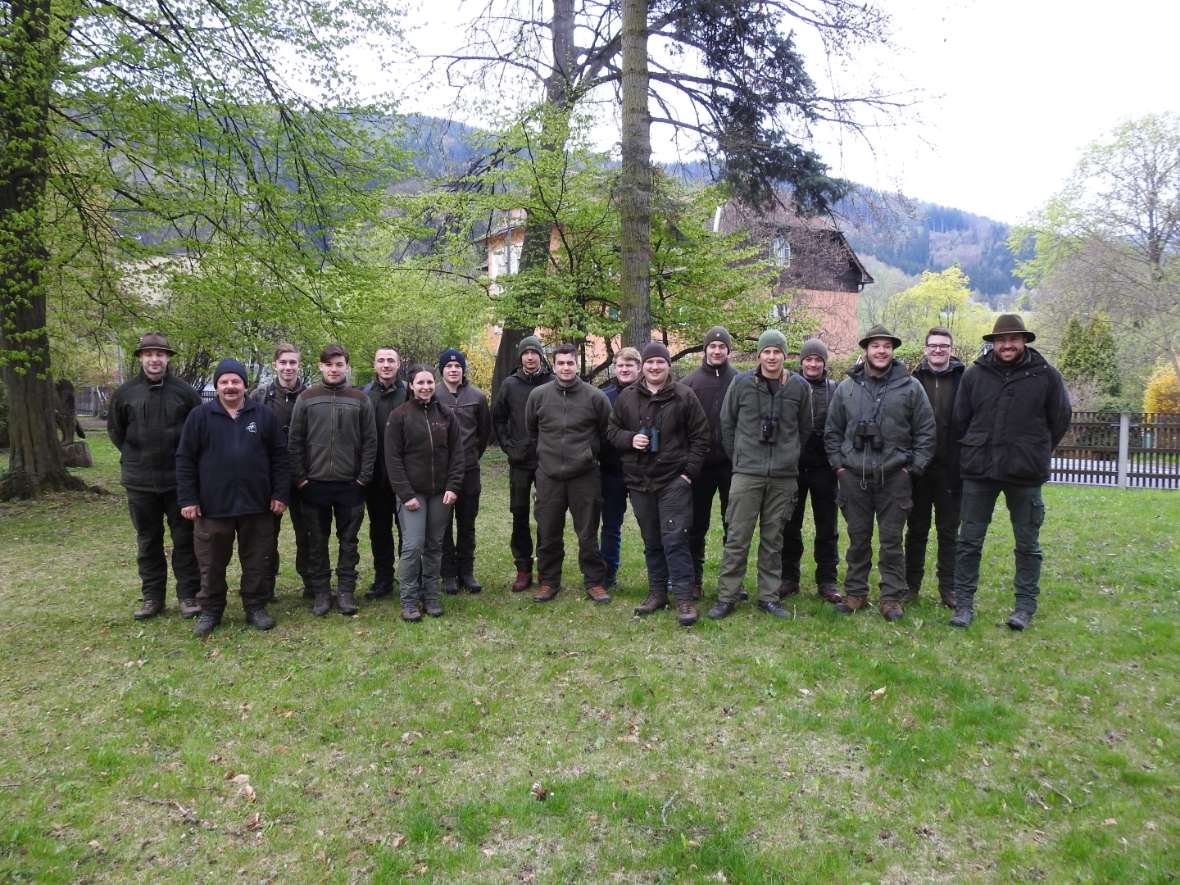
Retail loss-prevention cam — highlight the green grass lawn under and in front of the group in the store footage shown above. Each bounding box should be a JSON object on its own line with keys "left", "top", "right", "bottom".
{"left": 0, "top": 433, "right": 1180, "bottom": 883}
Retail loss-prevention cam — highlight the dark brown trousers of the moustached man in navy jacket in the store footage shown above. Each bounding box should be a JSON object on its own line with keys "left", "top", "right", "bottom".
{"left": 192, "top": 512, "right": 275, "bottom": 618}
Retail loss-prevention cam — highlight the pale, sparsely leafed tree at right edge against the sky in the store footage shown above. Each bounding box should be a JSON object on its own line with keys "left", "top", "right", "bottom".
{"left": 1010, "top": 113, "right": 1180, "bottom": 398}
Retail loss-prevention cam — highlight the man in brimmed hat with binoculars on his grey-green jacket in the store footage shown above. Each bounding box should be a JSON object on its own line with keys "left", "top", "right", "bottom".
{"left": 824, "top": 325, "right": 935, "bottom": 621}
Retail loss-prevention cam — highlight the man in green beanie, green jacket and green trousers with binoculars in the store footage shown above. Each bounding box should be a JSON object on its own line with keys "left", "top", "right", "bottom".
{"left": 708, "top": 329, "right": 811, "bottom": 620}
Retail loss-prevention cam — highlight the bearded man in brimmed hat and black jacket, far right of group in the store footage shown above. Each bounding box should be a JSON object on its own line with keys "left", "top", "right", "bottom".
{"left": 950, "top": 314, "right": 1073, "bottom": 630}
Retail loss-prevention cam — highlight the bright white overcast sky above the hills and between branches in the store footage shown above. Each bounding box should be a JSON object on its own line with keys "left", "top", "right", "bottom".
{"left": 394, "top": 0, "right": 1180, "bottom": 222}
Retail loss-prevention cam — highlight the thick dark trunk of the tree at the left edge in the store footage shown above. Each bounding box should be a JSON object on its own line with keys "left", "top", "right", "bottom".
{"left": 0, "top": 0, "right": 83, "bottom": 498}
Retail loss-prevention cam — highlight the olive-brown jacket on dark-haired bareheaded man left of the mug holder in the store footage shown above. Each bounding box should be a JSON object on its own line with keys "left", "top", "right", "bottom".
{"left": 525, "top": 378, "right": 610, "bottom": 479}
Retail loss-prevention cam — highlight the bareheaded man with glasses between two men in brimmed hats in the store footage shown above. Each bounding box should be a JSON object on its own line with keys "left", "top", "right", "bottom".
{"left": 902, "top": 326, "right": 966, "bottom": 609}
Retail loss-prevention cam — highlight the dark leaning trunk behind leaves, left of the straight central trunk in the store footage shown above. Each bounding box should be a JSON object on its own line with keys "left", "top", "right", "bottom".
{"left": 492, "top": 0, "right": 575, "bottom": 398}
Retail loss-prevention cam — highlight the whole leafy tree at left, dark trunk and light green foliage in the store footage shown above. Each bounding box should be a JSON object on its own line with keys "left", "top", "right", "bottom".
{"left": 0, "top": 0, "right": 399, "bottom": 494}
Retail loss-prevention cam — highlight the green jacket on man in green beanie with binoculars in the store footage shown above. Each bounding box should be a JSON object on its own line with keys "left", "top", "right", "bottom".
{"left": 721, "top": 369, "right": 811, "bottom": 477}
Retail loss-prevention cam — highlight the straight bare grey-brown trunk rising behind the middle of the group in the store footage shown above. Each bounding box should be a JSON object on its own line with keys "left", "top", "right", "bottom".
{"left": 620, "top": 0, "right": 651, "bottom": 349}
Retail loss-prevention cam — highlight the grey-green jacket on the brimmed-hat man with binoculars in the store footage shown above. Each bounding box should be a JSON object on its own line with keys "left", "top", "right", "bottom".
{"left": 824, "top": 360, "right": 935, "bottom": 478}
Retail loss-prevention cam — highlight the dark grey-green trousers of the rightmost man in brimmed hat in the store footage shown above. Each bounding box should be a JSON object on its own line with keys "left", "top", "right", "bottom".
{"left": 955, "top": 479, "right": 1044, "bottom": 612}
